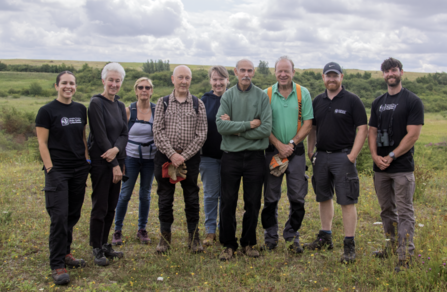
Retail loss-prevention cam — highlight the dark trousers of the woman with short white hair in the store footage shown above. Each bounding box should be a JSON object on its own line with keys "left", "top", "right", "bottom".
{"left": 90, "top": 160, "right": 124, "bottom": 248}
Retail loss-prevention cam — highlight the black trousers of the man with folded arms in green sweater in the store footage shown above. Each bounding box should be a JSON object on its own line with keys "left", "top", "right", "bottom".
{"left": 219, "top": 151, "right": 265, "bottom": 250}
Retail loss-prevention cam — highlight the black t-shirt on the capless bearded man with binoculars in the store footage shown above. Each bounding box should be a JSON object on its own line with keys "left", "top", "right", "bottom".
{"left": 369, "top": 88, "right": 424, "bottom": 173}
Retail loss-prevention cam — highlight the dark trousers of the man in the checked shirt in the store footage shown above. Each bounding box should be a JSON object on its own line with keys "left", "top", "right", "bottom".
{"left": 154, "top": 151, "right": 200, "bottom": 233}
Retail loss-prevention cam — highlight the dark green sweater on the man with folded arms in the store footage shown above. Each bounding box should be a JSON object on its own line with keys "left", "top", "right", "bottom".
{"left": 216, "top": 84, "right": 272, "bottom": 152}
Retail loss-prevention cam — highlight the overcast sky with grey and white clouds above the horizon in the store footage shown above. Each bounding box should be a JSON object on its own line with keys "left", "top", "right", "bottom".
{"left": 0, "top": 0, "right": 447, "bottom": 72}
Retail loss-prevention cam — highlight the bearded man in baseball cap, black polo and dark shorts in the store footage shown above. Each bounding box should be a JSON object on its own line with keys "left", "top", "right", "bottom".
{"left": 304, "top": 62, "right": 368, "bottom": 262}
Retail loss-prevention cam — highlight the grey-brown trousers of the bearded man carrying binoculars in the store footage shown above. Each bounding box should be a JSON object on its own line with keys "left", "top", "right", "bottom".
{"left": 374, "top": 172, "right": 415, "bottom": 260}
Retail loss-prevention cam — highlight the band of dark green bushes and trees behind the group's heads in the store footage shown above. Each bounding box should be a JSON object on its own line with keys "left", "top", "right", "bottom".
{"left": 0, "top": 60, "right": 447, "bottom": 112}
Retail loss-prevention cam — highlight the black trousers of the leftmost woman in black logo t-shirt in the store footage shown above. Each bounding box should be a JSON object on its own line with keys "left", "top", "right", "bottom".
{"left": 44, "top": 162, "right": 90, "bottom": 270}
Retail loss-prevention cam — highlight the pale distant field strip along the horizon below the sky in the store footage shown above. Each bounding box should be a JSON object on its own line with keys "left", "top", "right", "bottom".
{"left": 0, "top": 59, "right": 434, "bottom": 81}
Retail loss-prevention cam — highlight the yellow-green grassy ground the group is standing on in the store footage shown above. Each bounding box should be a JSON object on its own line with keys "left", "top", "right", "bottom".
{"left": 0, "top": 110, "right": 447, "bottom": 291}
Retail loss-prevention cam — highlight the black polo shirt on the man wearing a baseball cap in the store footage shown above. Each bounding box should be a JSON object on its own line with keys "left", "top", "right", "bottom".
{"left": 312, "top": 87, "right": 368, "bottom": 151}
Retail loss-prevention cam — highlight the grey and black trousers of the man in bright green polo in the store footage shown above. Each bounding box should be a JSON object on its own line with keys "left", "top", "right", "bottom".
{"left": 261, "top": 149, "right": 308, "bottom": 245}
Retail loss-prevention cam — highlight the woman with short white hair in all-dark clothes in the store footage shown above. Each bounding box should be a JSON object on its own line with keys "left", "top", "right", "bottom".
{"left": 88, "top": 63, "right": 128, "bottom": 266}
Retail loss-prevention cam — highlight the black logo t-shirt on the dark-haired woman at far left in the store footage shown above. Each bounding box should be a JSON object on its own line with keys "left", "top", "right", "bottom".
{"left": 36, "top": 100, "right": 87, "bottom": 168}
